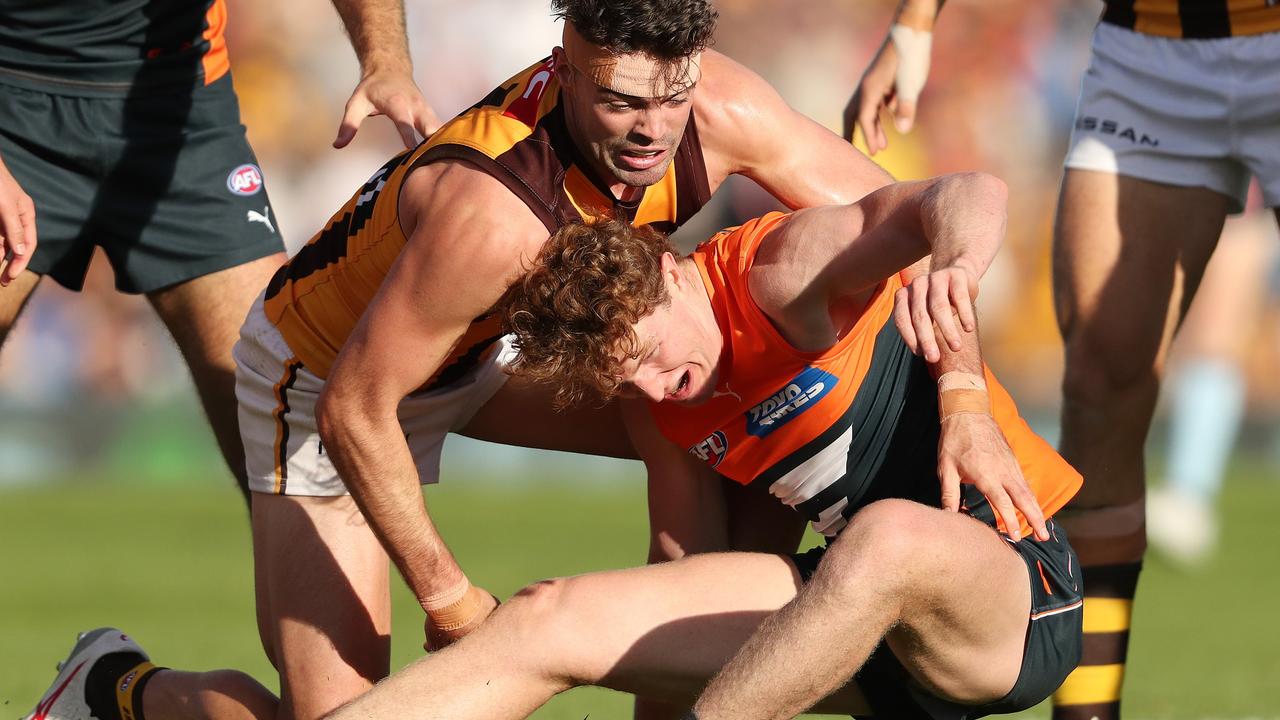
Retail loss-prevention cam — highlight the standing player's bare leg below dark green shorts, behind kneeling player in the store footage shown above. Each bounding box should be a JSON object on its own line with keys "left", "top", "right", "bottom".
{"left": 147, "top": 252, "right": 284, "bottom": 500}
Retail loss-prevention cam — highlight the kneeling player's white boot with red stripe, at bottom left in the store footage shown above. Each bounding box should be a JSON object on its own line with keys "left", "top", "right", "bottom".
{"left": 23, "top": 628, "right": 148, "bottom": 720}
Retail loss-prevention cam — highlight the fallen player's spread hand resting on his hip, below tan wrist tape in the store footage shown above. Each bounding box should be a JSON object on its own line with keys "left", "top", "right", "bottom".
{"left": 938, "top": 413, "right": 1050, "bottom": 541}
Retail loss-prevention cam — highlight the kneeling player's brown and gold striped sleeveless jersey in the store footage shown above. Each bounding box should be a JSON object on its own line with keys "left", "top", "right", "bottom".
{"left": 264, "top": 59, "right": 710, "bottom": 389}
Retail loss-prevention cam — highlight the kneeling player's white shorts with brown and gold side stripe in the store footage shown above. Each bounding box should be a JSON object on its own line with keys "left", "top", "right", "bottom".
{"left": 233, "top": 296, "right": 516, "bottom": 496}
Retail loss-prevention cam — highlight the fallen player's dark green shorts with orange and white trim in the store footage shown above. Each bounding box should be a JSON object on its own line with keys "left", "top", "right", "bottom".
{"left": 791, "top": 512, "right": 1084, "bottom": 720}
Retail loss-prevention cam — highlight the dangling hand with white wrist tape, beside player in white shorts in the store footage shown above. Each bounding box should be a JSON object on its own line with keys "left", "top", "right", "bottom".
{"left": 844, "top": 0, "right": 943, "bottom": 149}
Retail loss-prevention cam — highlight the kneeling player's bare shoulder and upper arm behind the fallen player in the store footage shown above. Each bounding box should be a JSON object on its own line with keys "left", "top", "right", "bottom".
{"left": 694, "top": 50, "right": 893, "bottom": 209}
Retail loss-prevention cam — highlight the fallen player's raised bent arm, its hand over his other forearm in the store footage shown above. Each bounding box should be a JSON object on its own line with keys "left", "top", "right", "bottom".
{"left": 750, "top": 173, "right": 1007, "bottom": 360}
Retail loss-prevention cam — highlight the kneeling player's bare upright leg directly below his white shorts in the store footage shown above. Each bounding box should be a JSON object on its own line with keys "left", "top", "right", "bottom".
{"left": 252, "top": 492, "right": 390, "bottom": 720}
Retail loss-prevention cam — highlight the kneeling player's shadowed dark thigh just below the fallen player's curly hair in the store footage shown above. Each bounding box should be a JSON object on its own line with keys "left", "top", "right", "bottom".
{"left": 461, "top": 377, "right": 637, "bottom": 459}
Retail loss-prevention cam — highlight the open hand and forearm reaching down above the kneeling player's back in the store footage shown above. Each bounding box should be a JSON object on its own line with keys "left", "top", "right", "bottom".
{"left": 333, "top": 0, "right": 440, "bottom": 147}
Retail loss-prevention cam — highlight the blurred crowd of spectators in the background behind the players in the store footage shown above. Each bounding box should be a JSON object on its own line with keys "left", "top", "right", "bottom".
{"left": 0, "top": 0, "right": 1280, "bottom": 484}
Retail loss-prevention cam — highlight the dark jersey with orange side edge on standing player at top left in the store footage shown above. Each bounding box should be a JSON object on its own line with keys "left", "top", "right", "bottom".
{"left": 0, "top": 0, "right": 230, "bottom": 96}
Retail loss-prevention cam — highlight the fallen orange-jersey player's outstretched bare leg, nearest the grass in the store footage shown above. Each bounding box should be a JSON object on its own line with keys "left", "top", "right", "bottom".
{"left": 334, "top": 553, "right": 865, "bottom": 720}
